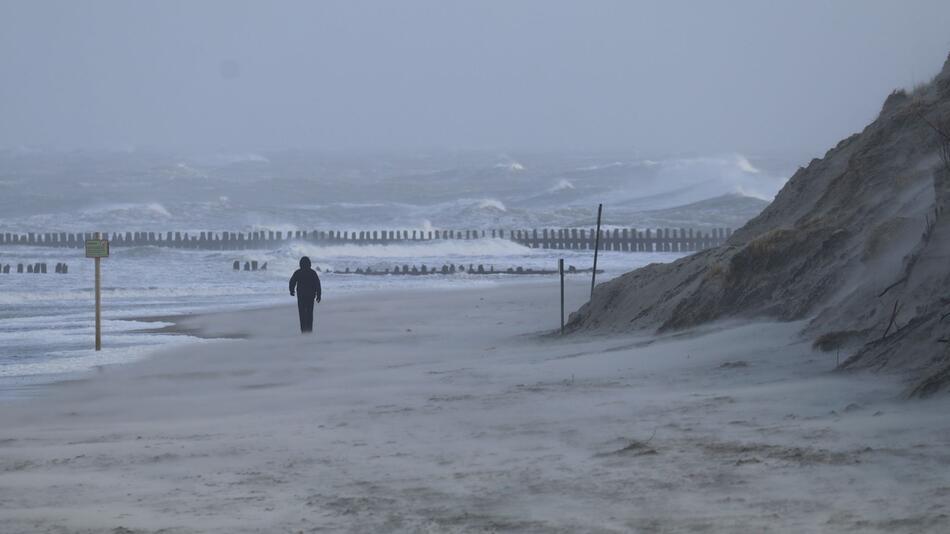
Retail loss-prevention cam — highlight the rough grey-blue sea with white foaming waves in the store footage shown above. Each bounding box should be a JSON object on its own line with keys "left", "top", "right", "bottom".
{"left": 0, "top": 147, "right": 795, "bottom": 398}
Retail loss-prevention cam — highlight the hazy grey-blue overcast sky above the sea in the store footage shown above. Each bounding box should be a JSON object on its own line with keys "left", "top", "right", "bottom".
{"left": 0, "top": 0, "right": 950, "bottom": 154}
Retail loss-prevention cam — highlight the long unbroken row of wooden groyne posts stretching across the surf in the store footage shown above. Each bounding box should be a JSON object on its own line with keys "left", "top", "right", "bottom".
{"left": 0, "top": 228, "right": 732, "bottom": 252}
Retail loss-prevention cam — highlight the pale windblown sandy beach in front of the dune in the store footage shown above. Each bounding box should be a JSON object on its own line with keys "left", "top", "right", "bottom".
{"left": 0, "top": 284, "right": 950, "bottom": 533}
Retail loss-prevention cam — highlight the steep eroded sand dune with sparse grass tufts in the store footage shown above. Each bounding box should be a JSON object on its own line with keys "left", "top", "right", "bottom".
{"left": 569, "top": 54, "right": 950, "bottom": 395}
